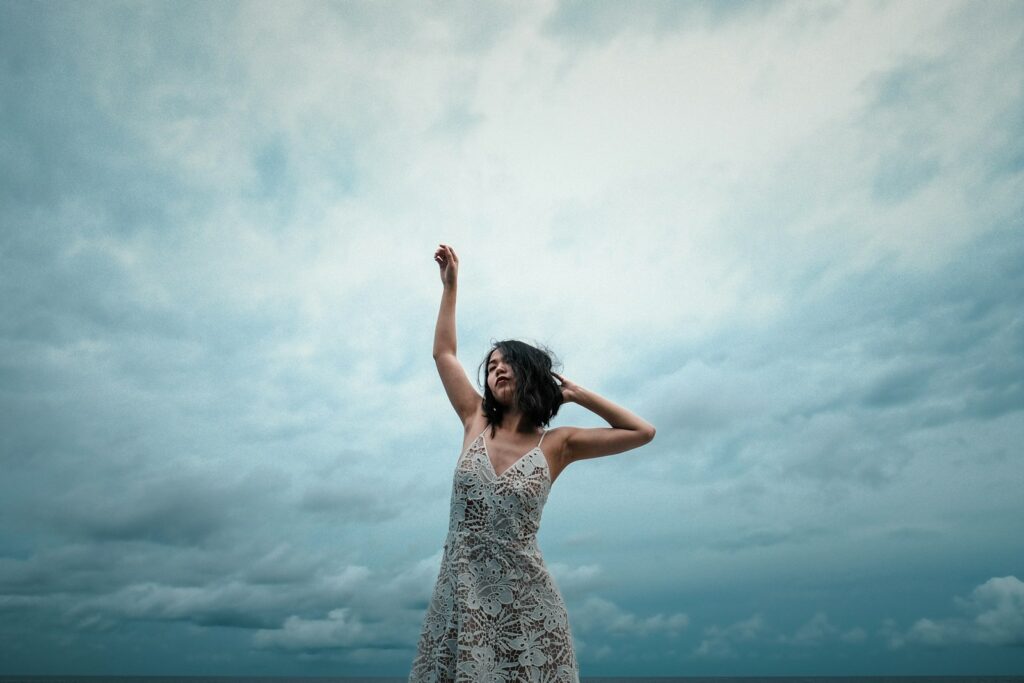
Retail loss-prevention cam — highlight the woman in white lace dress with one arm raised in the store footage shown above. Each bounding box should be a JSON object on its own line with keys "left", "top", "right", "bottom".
{"left": 409, "top": 244, "right": 654, "bottom": 683}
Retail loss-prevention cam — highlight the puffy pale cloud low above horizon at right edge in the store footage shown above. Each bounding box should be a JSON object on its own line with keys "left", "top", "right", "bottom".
{"left": 885, "top": 575, "right": 1024, "bottom": 648}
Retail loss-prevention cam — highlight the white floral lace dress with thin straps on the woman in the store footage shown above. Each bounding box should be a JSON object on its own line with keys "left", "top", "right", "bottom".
{"left": 409, "top": 427, "right": 580, "bottom": 683}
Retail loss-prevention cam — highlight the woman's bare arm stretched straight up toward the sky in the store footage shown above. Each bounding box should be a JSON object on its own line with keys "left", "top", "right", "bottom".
{"left": 434, "top": 245, "right": 483, "bottom": 427}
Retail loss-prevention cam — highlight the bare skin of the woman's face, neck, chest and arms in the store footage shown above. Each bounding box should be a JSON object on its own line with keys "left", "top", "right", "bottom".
{"left": 433, "top": 244, "right": 654, "bottom": 482}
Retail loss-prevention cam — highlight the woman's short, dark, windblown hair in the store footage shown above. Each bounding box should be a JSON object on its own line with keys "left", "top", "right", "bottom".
{"left": 476, "top": 339, "right": 562, "bottom": 435}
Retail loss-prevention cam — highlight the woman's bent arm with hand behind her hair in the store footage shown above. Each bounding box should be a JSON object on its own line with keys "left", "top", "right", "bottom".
{"left": 552, "top": 373, "right": 654, "bottom": 465}
